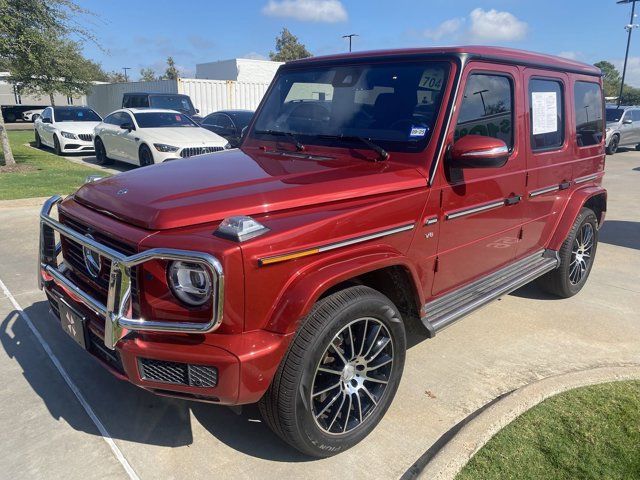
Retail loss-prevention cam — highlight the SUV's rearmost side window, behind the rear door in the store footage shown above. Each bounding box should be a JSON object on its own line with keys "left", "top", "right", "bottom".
{"left": 573, "top": 82, "right": 604, "bottom": 147}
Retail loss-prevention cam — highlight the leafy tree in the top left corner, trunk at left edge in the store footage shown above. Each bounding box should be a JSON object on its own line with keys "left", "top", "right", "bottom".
{"left": 0, "top": 0, "right": 95, "bottom": 165}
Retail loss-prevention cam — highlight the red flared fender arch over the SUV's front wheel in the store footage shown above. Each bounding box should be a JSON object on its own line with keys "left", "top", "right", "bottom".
{"left": 266, "top": 244, "right": 424, "bottom": 334}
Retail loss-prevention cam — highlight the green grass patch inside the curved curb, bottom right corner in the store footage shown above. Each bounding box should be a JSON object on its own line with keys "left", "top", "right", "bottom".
{"left": 457, "top": 381, "right": 640, "bottom": 480}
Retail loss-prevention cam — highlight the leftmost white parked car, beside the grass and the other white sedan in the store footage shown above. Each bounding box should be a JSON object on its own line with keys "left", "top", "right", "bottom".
{"left": 35, "top": 106, "right": 102, "bottom": 155}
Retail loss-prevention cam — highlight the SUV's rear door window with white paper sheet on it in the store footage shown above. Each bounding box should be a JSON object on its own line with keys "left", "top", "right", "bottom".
{"left": 529, "top": 78, "right": 564, "bottom": 151}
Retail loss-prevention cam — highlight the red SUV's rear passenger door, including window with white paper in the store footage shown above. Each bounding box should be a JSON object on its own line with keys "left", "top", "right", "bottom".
{"left": 517, "top": 69, "right": 573, "bottom": 256}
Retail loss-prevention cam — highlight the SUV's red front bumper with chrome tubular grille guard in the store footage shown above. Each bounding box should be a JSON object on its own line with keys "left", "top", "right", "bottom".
{"left": 38, "top": 196, "right": 291, "bottom": 404}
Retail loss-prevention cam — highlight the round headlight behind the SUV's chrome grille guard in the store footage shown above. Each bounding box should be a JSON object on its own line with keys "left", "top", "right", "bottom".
{"left": 167, "top": 261, "right": 212, "bottom": 307}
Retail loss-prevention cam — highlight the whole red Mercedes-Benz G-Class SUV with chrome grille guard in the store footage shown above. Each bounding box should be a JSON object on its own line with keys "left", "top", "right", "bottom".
{"left": 39, "top": 47, "right": 606, "bottom": 456}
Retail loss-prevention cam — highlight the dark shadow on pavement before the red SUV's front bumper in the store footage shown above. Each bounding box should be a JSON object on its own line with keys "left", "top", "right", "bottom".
{"left": 0, "top": 301, "right": 312, "bottom": 462}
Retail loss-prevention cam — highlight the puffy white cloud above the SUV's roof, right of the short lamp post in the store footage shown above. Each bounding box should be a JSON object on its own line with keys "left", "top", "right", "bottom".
{"left": 423, "top": 8, "right": 529, "bottom": 43}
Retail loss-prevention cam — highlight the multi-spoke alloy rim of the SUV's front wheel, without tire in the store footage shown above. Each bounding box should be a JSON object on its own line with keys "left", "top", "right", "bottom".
{"left": 310, "top": 317, "right": 394, "bottom": 435}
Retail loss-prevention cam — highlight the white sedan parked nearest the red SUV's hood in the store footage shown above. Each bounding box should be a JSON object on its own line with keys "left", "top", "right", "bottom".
{"left": 94, "top": 108, "right": 230, "bottom": 167}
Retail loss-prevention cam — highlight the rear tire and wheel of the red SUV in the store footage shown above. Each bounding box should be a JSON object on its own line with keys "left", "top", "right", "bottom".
{"left": 538, "top": 208, "right": 598, "bottom": 298}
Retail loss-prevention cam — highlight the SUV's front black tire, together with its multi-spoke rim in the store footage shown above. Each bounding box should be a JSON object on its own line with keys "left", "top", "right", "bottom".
{"left": 259, "top": 286, "right": 406, "bottom": 457}
